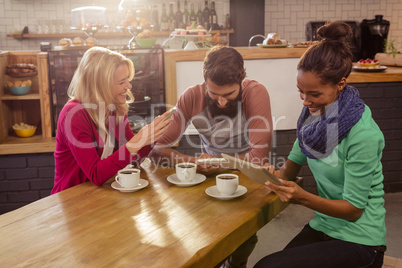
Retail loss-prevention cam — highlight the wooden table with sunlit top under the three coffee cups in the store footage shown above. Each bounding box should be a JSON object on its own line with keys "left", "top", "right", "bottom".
{"left": 0, "top": 165, "right": 296, "bottom": 267}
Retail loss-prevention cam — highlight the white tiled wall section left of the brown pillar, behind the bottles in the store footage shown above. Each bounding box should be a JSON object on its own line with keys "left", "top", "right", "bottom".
{"left": 0, "top": 0, "right": 229, "bottom": 50}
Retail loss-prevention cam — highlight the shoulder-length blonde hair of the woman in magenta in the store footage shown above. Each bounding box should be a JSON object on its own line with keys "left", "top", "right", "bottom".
{"left": 67, "top": 47, "right": 135, "bottom": 133}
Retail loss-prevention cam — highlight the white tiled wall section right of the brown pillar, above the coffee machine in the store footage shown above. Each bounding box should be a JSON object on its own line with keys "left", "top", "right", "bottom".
{"left": 265, "top": 0, "right": 402, "bottom": 47}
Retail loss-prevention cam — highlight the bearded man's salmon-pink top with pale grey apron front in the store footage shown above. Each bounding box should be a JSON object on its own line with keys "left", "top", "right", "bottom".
{"left": 158, "top": 80, "right": 272, "bottom": 165}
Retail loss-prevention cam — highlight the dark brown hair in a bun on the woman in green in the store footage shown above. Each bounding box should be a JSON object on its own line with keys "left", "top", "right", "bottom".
{"left": 297, "top": 21, "right": 353, "bottom": 85}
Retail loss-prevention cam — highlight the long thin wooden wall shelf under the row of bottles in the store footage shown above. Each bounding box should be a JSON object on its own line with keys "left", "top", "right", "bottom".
{"left": 7, "top": 30, "right": 234, "bottom": 40}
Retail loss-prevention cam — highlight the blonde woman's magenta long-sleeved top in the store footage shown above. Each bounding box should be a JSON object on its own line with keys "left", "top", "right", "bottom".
{"left": 52, "top": 100, "right": 151, "bottom": 194}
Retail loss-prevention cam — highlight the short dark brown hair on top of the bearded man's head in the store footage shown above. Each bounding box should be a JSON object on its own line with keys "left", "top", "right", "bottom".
{"left": 203, "top": 45, "right": 246, "bottom": 86}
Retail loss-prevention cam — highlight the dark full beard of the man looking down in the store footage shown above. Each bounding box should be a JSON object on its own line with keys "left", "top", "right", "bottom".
{"left": 205, "top": 88, "right": 242, "bottom": 119}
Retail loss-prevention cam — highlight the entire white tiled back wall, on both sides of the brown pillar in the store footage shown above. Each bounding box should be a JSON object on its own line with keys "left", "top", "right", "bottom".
{"left": 0, "top": 0, "right": 402, "bottom": 50}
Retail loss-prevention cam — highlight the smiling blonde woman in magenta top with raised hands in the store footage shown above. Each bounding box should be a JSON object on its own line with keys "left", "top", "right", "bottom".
{"left": 52, "top": 47, "right": 171, "bottom": 194}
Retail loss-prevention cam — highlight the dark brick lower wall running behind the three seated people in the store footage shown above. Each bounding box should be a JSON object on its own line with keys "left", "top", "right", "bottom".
{"left": 0, "top": 83, "right": 402, "bottom": 214}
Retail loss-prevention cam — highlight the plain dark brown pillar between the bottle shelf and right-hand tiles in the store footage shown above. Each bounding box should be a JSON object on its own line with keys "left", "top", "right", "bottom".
{"left": 229, "top": 0, "right": 265, "bottom": 47}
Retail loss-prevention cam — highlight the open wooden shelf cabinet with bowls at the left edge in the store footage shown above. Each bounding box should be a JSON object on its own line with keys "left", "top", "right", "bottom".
{"left": 0, "top": 51, "right": 52, "bottom": 154}
